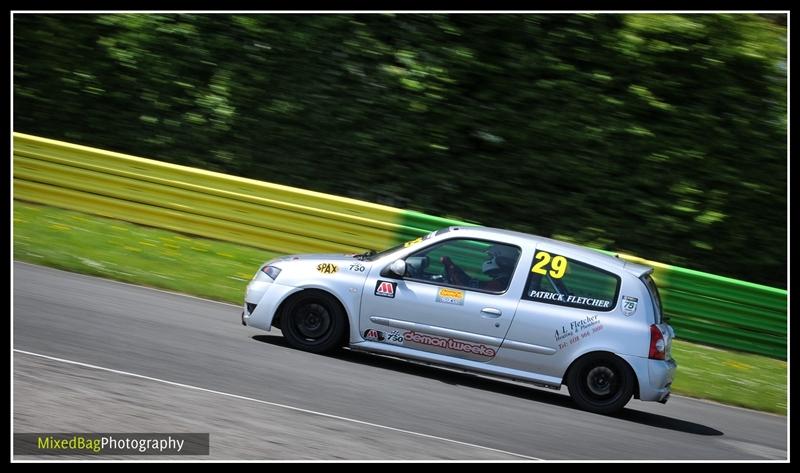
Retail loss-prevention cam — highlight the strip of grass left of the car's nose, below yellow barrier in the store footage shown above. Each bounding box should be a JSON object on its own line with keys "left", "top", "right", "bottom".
{"left": 14, "top": 201, "right": 277, "bottom": 304}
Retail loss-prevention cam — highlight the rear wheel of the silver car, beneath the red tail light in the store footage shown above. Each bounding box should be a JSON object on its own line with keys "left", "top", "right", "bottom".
{"left": 567, "top": 353, "right": 635, "bottom": 414}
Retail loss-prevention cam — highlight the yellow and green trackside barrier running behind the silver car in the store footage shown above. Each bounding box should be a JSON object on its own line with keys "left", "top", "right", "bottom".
{"left": 14, "top": 133, "right": 788, "bottom": 359}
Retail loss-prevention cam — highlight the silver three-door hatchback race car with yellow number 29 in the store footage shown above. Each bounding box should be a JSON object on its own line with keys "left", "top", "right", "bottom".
{"left": 242, "top": 227, "right": 677, "bottom": 414}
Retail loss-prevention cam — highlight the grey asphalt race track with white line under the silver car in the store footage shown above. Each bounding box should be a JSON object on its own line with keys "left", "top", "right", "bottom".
{"left": 13, "top": 263, "right": 787, "bottom": 461}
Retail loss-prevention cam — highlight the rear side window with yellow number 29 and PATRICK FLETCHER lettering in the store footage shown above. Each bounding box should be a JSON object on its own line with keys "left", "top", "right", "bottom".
{"left": 522, "top": 251, "right": 620, "bottom": 312}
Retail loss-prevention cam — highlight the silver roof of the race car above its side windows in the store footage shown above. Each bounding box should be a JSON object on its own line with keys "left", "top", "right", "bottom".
{"left": 445, "top": 226, "right": 650, "bottom": 276}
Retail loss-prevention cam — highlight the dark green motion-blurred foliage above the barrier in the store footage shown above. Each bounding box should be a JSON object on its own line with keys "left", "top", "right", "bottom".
{"left": 13, "top": 14, "right": 788, "bottom": 287}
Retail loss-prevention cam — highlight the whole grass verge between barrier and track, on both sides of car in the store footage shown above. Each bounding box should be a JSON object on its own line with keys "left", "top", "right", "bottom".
{"left": 14, "top": 201, "right": 787, "bottom": 415}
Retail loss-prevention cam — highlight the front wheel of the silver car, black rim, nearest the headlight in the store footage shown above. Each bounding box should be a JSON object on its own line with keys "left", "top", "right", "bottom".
{"left": 281, "top": 291, "right": 347, "bottom": 353}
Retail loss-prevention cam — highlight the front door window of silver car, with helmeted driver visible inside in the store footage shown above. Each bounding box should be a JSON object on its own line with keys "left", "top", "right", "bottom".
{"left": 406, "top": 239, "right": 521, "bottom": 293}
